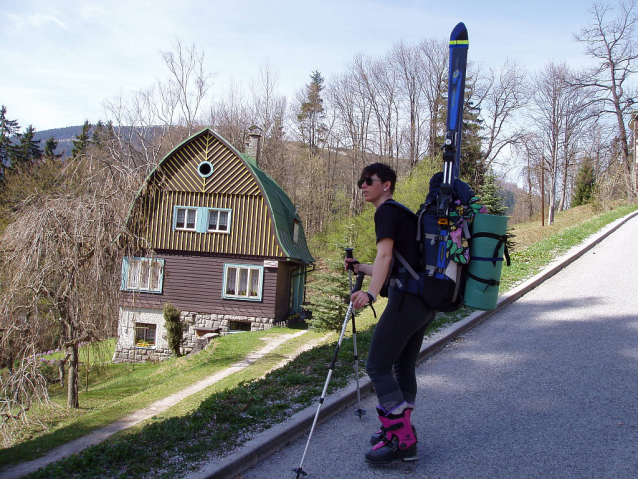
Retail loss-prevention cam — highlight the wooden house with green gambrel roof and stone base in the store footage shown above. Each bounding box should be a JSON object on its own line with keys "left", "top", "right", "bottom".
{"left": 113, "top": 129, "right": 314, "bottom": 361}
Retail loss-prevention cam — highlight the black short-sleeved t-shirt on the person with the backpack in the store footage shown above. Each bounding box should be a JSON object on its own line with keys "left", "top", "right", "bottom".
{"left": 374, "top": 202, "right": 421, "bottom": 276}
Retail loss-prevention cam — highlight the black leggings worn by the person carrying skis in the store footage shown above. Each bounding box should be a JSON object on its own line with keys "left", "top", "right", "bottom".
{"left": 366, "top": 287, "right": 436, "bottom": 411}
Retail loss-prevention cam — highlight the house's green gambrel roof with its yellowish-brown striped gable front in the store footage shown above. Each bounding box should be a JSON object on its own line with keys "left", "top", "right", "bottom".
{"left": 129, "top": 128, "right": 314, "bottom": 264}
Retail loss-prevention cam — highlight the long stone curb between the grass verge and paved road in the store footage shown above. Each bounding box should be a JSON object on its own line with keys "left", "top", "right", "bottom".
{"left": 186, "top": 211, "right": 638, "bottom": 479}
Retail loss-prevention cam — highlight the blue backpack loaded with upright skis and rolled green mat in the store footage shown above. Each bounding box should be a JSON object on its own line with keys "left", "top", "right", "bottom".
{"left": 394, "top": 23, "right": 509, "bottom": 312}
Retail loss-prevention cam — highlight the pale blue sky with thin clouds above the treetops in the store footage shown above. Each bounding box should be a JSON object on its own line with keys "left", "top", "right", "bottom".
{"left": 0, "top": 0, "right": 604, "bottom": 131}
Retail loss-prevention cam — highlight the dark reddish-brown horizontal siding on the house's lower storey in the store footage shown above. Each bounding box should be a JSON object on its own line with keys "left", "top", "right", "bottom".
{"left": 120, "top": 252, "right": 295, "bottom": 320}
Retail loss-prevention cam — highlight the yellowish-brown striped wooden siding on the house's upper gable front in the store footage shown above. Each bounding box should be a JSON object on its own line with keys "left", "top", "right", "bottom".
{"left": 131, "top": 131, "right": 285, "bottom": 258}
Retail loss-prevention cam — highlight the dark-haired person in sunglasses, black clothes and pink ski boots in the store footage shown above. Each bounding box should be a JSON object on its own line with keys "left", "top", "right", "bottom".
{"left": 346, "top": 163, "right": 436, "bottom": 464}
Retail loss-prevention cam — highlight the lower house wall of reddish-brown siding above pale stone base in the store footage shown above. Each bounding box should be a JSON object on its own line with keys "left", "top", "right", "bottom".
{"left": 113, "top": 255, "right": 296, "bottom": 362}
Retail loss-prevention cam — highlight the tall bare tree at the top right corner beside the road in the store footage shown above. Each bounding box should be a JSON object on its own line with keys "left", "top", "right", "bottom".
{"left": 575, "top": 0, "right": 638, "bottom": 200}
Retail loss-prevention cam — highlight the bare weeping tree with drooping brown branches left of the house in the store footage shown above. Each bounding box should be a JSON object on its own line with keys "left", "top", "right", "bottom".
{"left": 0, "top": 144, "right": 139, "bottom": 414}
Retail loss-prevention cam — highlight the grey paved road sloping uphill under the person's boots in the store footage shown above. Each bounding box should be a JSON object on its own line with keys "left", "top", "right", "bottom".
{"left": 238, "top": 217, "right": 638, "bottom": 479}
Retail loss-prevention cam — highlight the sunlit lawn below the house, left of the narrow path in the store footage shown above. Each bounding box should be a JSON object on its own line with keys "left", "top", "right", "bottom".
{"left": 0, "top": 328, "right": 330, "bottom": 465}
